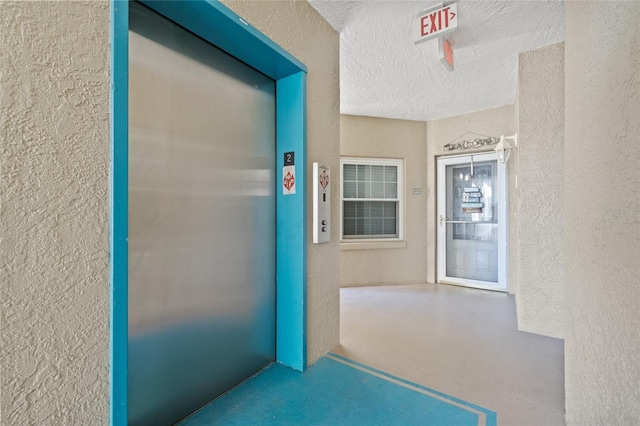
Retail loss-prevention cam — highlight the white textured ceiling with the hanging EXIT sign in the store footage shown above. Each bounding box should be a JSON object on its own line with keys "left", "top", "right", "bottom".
{"left": 308, "top": 0, "right": 564, "bottom": 121}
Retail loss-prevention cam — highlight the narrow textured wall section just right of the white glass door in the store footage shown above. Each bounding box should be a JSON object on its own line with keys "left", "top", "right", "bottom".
{"left": 511, "top": 43, "right": 564, "bottom": 337}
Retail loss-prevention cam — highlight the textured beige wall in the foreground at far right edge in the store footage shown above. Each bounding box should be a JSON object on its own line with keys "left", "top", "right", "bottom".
{"left": 564, "top": 2, "right": 640, "bottom": 426}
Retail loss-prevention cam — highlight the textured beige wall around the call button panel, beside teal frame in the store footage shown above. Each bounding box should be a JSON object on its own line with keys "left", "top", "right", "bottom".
{"left": 225, "top": 0, "right": 340, "bottom": 363}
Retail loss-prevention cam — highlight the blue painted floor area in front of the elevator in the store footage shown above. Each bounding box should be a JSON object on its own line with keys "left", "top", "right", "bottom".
{"left": 181, "top": 354, "right": 496, "bottom": 426}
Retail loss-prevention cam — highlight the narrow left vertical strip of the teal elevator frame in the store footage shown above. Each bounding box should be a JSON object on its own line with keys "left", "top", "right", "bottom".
{"left": 110, "top": 1, "right": 129, "bottom": 426}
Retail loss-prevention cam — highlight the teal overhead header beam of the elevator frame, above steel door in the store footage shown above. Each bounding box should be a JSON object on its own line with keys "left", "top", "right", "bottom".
{"left": 140, "top": 0, "right": 307, "bottom": 80}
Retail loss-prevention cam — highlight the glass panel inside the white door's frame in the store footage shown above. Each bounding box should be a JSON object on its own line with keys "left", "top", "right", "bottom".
{"left": 446, "top": 161, "right": 498, "bottom": 282}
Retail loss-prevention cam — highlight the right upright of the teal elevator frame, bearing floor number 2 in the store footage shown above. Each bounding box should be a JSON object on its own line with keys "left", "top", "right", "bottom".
{"left": 276, "top": 72, "right": 307, "bottom": 371}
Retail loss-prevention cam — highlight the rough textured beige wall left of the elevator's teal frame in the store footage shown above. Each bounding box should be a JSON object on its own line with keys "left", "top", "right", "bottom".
{"left": 0, "top": 1, "right": 109, "bottom": 425}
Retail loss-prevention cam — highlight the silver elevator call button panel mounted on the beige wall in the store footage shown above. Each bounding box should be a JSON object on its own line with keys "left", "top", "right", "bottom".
{"left": 313, "top": 163, "right": 331, "bottom": 244}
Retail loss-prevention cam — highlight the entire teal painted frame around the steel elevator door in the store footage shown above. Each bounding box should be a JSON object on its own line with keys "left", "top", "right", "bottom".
{"left": 110, "top": 0, "right": 307, "bottom": 425}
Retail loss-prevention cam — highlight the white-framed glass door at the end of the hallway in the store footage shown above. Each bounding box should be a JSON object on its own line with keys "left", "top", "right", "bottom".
{"left": 437, "top": 152, "right": 508, "bottom": 291}
